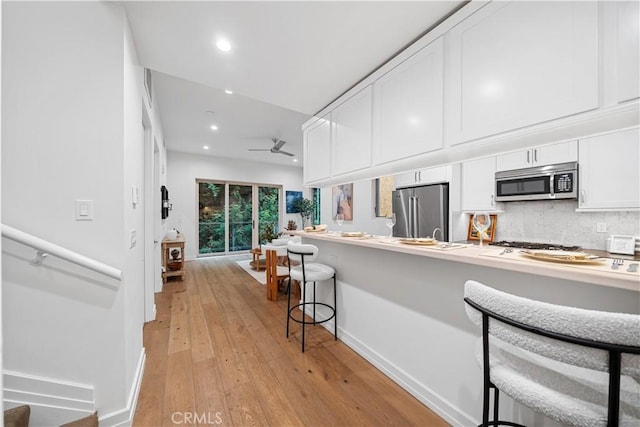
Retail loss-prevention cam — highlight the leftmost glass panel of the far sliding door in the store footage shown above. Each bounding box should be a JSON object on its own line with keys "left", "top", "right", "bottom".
{"left": 198, "top": 182, "right": 226, "bottom": 254}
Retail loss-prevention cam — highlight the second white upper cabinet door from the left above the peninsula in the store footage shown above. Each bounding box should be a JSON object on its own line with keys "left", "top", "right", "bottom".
{"left": 331, "top": 86, "right": 372, "bottom": 175}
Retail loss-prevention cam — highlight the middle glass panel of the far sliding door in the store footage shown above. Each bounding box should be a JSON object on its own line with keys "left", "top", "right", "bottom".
{"left": 229, "top": 184, "right": 253, "bottom": 252}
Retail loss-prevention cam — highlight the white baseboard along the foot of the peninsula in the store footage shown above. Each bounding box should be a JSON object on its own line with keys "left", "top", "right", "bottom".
{"left": 305, "top": 307, "right": 478, "bottom": 427}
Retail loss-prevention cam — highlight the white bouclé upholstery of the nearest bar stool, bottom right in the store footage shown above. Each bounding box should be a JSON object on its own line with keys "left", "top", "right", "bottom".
{"left": 465, "top": 280, "right": 640, "bottom": 427}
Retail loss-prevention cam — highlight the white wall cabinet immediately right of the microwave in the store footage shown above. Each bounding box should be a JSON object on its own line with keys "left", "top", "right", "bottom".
{"left": 578, "top": 128, "right": 640, "bottom": 210}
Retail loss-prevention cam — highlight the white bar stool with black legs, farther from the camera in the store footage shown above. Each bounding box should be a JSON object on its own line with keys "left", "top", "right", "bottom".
{"left": 287, "top": 242, "right": 338, "bottom": 353}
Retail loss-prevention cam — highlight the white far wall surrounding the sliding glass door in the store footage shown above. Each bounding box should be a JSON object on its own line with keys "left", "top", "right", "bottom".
{"left": 167, "top": 151, "right": 310, "bottom": 259}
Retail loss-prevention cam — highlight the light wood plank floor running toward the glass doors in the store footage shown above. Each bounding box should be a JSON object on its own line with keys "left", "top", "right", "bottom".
{"left": 133, "top": 258, "right": 447, "bottom": 427}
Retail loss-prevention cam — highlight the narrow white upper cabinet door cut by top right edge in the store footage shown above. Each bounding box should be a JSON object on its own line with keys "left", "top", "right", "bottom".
{"left": 616, "top": 1, "right": 640, "bottom": 102}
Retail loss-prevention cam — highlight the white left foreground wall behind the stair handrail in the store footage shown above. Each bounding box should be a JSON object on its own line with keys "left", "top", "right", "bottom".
{"left": 2, "top": 2, "right": 159, "bottom": 425}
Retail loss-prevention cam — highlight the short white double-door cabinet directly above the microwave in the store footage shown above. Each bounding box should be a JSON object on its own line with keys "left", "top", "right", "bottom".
{"left": 496, "top": 141, "right": 578, "bottom": 171}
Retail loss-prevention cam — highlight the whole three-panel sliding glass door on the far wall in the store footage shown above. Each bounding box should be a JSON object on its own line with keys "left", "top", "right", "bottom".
{"left": 197, "top": 181, "right": 281, "bottom": 255}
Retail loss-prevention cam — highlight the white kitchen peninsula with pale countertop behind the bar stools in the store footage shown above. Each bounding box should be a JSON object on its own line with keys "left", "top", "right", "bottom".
{"left": 295, "top": 232, "right": 640, "bottom": 426}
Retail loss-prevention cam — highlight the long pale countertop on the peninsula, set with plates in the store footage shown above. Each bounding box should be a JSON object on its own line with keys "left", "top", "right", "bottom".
{"left": 288, "top": 231, "right": 640, "bottom": 292}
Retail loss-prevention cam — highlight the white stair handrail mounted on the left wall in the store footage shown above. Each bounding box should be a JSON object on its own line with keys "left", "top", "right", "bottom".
{"left": 2, "top": 224, "right": 122, "bottom": 280}
